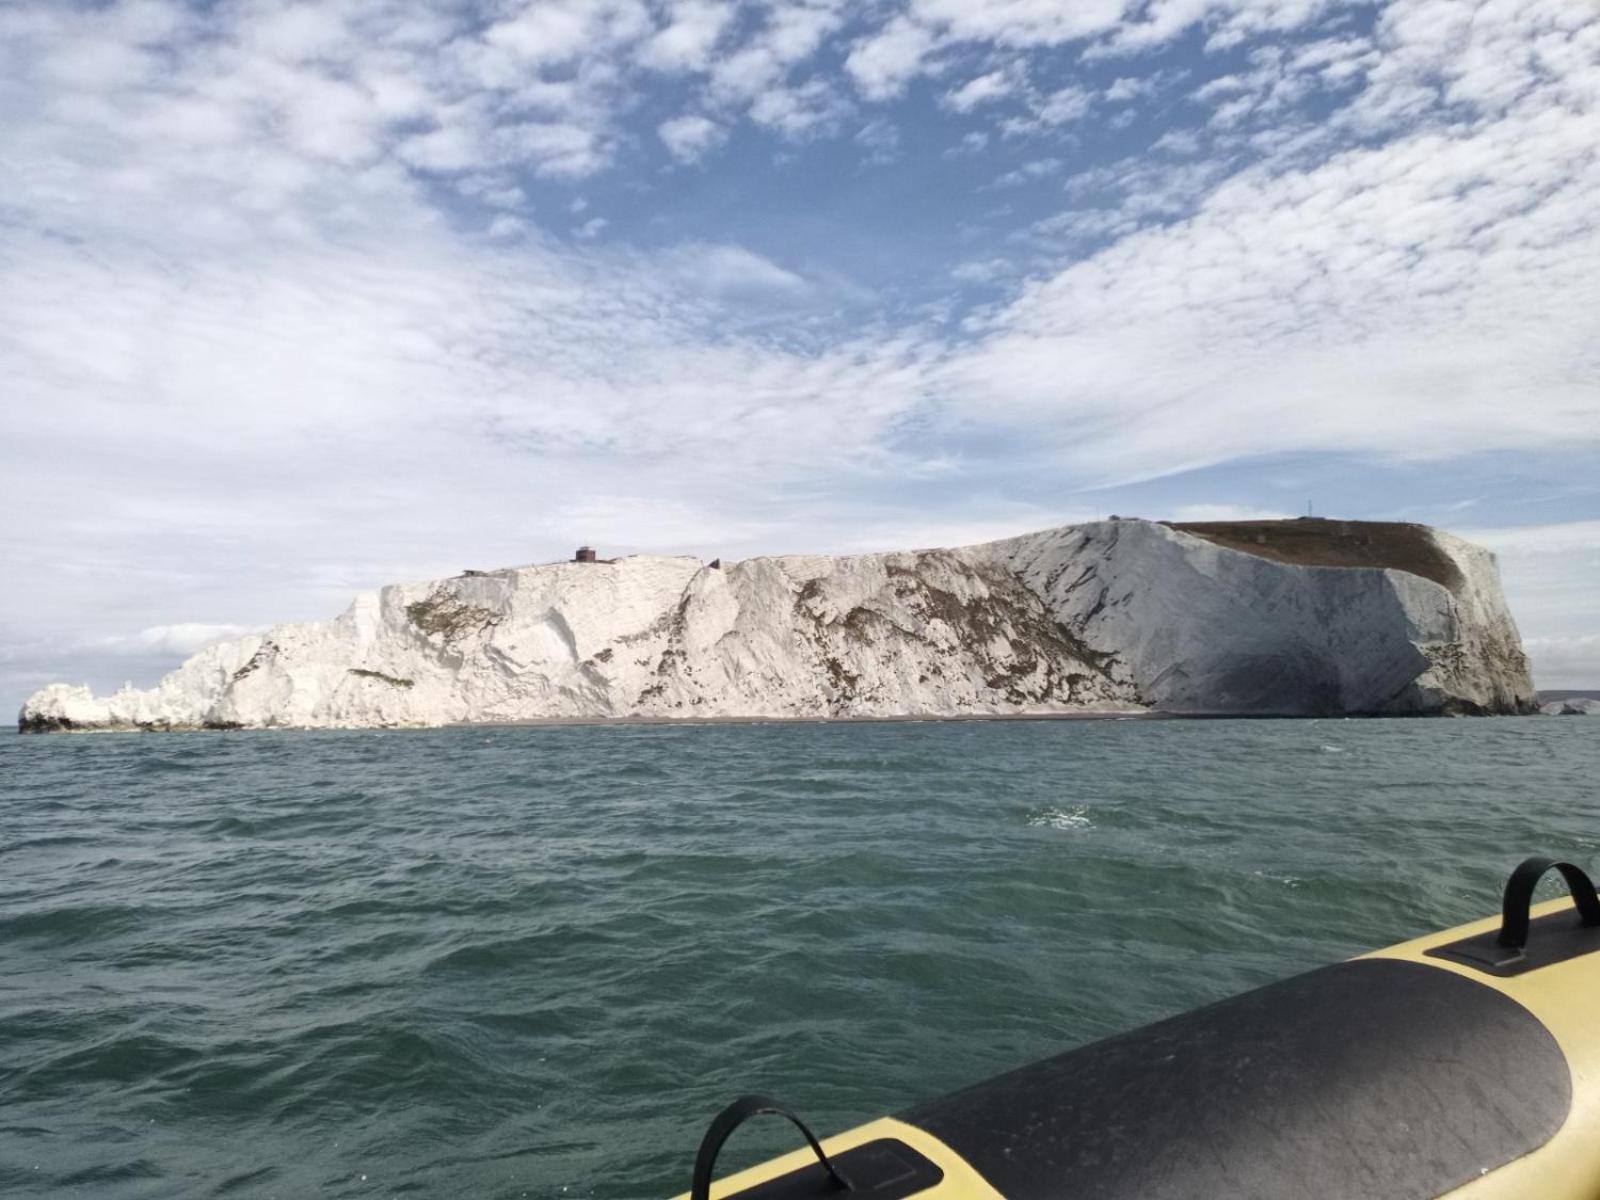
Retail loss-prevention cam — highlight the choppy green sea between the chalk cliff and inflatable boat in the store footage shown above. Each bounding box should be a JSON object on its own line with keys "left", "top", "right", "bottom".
{"left": 0, "top": 717, "right": 1600, "bottom": 1200}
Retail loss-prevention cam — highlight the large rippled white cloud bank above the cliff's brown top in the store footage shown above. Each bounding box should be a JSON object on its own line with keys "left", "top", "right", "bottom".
{"left": 947, "top": 0, "right": 1600, "bottom": 480}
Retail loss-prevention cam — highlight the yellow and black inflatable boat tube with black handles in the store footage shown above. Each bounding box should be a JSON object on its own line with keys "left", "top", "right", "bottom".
{"left": 683, "top": 858, "right": 1600, "bottom": 1200}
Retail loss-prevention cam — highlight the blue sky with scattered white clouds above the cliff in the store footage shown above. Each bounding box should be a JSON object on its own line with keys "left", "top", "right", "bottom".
{"left": 0, "top": 0, "right": 1600, "bottom": 709}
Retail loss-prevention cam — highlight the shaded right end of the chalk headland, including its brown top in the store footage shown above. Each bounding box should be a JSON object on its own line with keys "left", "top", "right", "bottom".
{"left": 997, "top": 520, "right": 1533, "bottom": 715}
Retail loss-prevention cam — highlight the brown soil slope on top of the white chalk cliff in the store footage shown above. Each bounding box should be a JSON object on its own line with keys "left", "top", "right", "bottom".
{"left": 1163, "top": 517, "right": 1462, "bottom": 592}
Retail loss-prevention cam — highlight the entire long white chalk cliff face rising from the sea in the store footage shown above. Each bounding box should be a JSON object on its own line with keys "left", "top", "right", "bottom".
{"left": 19, "top": 520, "right": 1533, "bottom": 731}
